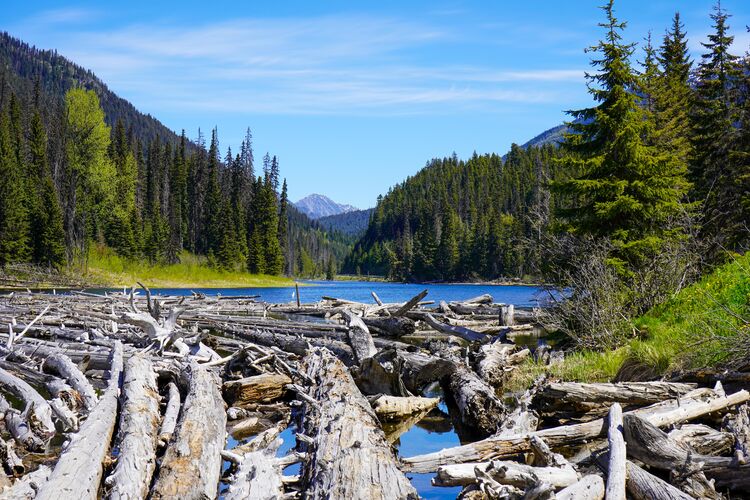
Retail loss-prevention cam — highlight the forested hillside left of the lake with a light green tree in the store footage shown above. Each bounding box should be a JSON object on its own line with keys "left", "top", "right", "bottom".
{"left": 0, "top": 33, "right": 345, "bottom": 275}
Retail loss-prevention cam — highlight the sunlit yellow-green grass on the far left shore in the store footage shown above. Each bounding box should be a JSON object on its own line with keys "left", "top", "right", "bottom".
{"left": 82, "top": 247, "right": 294, "bottom": 288}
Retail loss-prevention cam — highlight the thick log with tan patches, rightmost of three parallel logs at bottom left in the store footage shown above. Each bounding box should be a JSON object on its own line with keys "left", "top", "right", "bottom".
{"left": 151, "top": 362, "right": 227, "bottom": 499}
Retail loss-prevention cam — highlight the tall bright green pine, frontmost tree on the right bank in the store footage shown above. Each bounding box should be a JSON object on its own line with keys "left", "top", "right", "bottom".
{"left": 553, "top": 0, "right": 688, "bottom": 272}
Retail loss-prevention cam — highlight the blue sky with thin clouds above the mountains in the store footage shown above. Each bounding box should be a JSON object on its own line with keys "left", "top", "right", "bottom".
{"left": 0, "top": 0, "right": 750, "bottom": 208}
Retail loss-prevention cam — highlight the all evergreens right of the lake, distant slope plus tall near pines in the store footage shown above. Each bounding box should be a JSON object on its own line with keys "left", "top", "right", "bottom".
{"left": 345, "top": 2, "right": 750, "bottom": 280}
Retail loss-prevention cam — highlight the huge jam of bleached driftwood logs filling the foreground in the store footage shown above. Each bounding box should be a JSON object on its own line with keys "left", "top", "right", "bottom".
{"left": 0, "top": 285, "right": 750, "bottom": 499}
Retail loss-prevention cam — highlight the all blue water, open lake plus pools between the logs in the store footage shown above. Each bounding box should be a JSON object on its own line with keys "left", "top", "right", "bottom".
{"left": 166, "top": 281, "right": 545, "bottom": 500}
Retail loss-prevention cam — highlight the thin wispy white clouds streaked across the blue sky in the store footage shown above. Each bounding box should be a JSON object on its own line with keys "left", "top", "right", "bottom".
{"left": 13, "top": 15, "right": 583, "bottom": 114}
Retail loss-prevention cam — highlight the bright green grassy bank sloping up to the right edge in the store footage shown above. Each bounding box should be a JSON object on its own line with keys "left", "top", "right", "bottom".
{"left": 510, "top": 252, "right": 750, "bottom": 388}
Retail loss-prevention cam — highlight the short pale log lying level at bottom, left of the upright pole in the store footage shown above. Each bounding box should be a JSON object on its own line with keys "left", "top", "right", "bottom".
{"left": 432, "top": 460, "right": 579, "bottom": 488}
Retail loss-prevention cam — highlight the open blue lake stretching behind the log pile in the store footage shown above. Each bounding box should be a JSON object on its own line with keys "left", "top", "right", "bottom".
{"left": 123, "top": 281, "right": 544, "bottom": 307}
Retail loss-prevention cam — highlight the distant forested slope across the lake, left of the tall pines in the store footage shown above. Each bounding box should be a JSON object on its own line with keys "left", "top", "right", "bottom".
{"left": 344, "top": 145, "right": 560, "bottom": 280}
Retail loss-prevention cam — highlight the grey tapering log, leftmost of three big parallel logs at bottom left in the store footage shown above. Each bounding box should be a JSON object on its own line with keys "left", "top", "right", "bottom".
{"left": 36, "top": 342, "right": 122, "bottom": 500}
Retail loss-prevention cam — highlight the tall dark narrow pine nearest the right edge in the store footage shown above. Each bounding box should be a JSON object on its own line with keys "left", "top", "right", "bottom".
{"left": 690, "top": 4, "right": 742, "bottom": 245}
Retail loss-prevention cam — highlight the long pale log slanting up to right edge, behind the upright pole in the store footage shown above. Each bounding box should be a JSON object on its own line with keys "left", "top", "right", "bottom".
{"left": 403, "top": 390, "right": 750, "bottom": 472}
